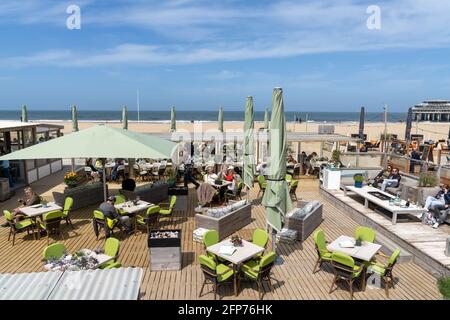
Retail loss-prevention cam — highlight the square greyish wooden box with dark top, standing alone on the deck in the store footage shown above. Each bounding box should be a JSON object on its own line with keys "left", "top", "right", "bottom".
{"left": 148, "top": 229, "right": 182, "bottom": 271}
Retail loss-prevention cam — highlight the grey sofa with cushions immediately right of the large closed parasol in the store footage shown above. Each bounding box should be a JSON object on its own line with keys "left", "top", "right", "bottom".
{"left": 285, "top": 200, "right": 323, "bottom": 241}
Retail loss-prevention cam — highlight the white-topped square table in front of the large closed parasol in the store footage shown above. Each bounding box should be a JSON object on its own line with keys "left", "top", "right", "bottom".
{"left": 206, "top": 239, "right": 264, "bottom": 296}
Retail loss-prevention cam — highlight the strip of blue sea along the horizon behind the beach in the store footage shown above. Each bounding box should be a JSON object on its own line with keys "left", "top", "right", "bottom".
{"left": 0, "top": 109, "right": 407, "bottom": 123}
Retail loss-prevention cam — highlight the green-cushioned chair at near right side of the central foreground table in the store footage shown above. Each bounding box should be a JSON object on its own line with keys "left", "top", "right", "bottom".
{"left": 241, "top": 251, "right": 277, "bottom": 299}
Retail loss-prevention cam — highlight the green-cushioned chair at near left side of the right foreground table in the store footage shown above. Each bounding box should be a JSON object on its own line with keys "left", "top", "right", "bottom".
{"left": 330, "top": 252, "right": 365, "bottom": 299}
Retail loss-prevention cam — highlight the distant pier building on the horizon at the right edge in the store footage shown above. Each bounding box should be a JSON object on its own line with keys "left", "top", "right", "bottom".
{"left": 412, "top": 100, "right": 450, "bottom": 122}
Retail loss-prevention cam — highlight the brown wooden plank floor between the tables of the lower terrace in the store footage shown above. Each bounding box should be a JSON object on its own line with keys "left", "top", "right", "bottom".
{"left": 0, "top": 176, "right": 440, "bottom": 300}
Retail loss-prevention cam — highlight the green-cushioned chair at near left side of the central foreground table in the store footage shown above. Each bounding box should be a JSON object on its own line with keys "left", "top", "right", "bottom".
{"left": 198, "top": 255, "right": 236, "bottom": 300}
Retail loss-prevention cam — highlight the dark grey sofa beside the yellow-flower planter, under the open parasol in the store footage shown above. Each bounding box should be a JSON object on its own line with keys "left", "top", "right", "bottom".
{"left": 53, "top": 182, "right": 108, "bottom": 210}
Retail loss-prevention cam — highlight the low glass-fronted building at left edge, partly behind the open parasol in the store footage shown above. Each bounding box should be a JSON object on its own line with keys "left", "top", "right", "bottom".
{"left": 0, "top": 121, "right": 64, "bottom": 187}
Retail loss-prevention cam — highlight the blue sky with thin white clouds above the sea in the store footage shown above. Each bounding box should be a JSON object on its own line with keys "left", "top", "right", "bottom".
{"left": 0, "top": 0, "right": 450, "bottom": 112}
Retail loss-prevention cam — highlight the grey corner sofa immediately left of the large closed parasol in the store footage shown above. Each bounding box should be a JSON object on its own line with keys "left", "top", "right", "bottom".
{"left": 195, "top": 204, "right": 252, "bottom": 240}
